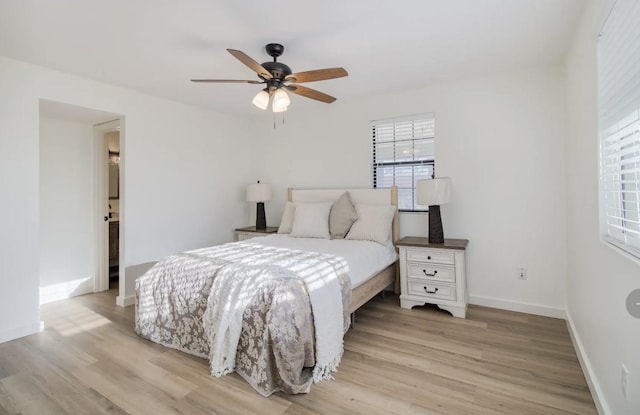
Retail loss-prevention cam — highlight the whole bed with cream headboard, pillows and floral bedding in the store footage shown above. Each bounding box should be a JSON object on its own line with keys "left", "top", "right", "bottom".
{"left": 135, "top": 188, "right": 398, "bottom": 396}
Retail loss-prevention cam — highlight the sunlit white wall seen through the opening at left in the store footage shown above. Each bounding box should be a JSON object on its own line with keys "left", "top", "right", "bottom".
{"left": 39, "top": 117, "right": 96, "bottom": 303}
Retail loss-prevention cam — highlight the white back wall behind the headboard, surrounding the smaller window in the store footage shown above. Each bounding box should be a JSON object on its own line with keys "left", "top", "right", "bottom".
{"left": 252, "top": 67, "right": 566, "bottom": 317}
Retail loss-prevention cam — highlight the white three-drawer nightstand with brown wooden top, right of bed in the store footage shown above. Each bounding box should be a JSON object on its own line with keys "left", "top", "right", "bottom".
{"left": 396, "top": 236, "right": 469, "bottom": 318}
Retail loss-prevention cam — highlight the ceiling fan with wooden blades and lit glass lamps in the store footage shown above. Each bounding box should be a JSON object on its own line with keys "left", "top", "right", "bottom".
{"left": 191, "top": 43, "right": 349, "bottom": 112}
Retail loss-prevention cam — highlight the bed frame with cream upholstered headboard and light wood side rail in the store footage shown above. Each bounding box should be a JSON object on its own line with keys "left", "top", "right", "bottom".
{"left": 288, "top": 186, "right": 400, "bottom": 314}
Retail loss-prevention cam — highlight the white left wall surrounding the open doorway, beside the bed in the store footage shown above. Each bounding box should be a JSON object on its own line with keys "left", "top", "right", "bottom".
{"left": 0, "top": 57, "right": 250, "bottom": 342}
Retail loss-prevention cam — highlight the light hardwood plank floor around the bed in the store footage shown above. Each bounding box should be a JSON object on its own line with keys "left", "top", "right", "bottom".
{"left": 0, "top": 292, "right": 596, "bottom": 415}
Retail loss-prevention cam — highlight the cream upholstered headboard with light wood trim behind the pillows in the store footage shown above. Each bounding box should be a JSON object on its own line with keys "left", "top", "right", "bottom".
{"left": 288, "top": 186, "right": 400, "bottom": 244}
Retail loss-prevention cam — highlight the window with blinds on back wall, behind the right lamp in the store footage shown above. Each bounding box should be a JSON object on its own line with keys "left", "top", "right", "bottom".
{"left": 371, "top": 113, "right": 435, "bottom": 211}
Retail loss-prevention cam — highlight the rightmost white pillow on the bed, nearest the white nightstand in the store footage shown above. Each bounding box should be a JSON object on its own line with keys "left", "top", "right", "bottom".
{"left": 344, "top": 204, "right": 396, "bottom": 245}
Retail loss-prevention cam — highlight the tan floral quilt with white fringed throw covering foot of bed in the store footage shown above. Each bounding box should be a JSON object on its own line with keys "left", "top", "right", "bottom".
{"left": 136, "top": 241, "right": 351, "bottom": 396}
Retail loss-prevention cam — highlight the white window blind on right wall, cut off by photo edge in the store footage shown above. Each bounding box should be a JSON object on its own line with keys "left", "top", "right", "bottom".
{"left": 598, "top": 0, "right": 640, "bottom": 258}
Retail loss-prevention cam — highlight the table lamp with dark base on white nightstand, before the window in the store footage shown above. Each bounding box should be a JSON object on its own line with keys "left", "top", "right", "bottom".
{"left": 416, "top": 177, "right": 451, "bottom": 244}
